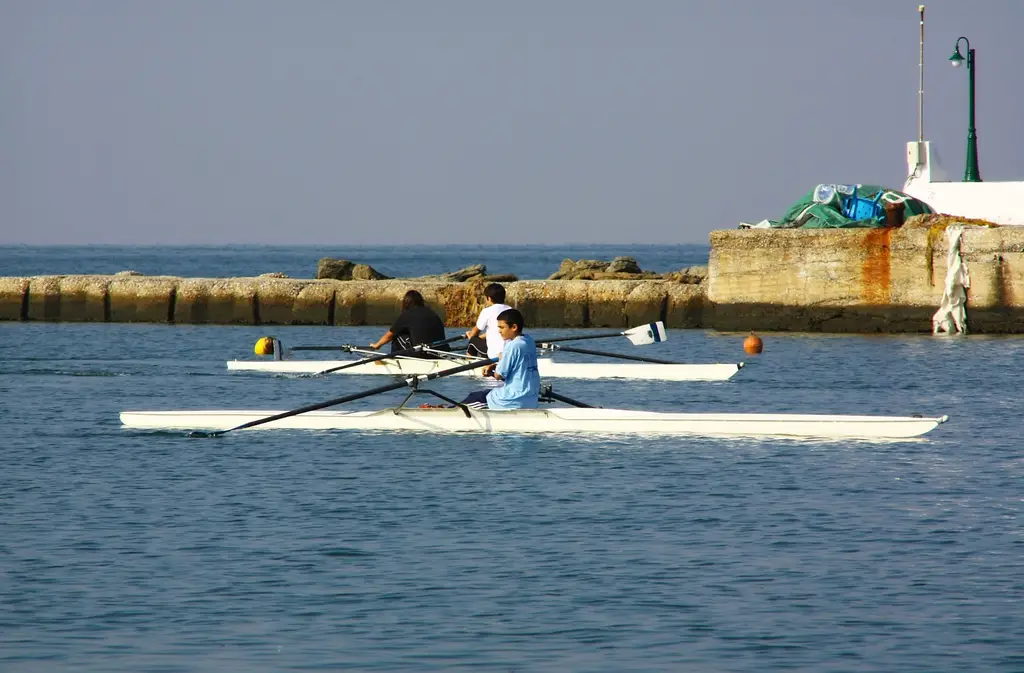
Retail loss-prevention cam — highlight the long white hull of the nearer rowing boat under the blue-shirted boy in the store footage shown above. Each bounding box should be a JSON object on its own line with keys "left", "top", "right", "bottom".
{"left": 121, "top": 408, "right": 948, "bottom": 439}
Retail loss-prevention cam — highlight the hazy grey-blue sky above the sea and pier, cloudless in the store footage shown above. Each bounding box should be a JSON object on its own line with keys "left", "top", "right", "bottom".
{"left": 0, "top": 0, "right": 1024, "bottom": 246}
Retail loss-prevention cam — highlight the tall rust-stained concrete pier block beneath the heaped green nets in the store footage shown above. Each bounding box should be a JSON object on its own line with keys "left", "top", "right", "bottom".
{"left": 703, "top": 226, "right": 1024, "bottom": 334}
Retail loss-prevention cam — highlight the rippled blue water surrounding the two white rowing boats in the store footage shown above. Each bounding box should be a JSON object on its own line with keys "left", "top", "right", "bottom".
{"left": 0, "top": 249, "right": 1024, "bottom": 673}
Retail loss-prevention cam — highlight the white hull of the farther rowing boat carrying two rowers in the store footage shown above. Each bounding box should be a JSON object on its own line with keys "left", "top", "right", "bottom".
{"left": 227, "top": 357, "right": 743, "bottom": 381}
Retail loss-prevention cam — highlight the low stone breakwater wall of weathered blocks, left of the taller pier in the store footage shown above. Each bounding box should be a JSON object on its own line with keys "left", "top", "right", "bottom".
{"left": 0, "top": 276, "right": 703, "bottom": 328}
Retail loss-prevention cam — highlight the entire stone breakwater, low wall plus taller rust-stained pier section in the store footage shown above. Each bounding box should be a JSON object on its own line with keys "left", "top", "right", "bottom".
{"left": 0, "top": 220, "right": 1024, "bottom": 333}
